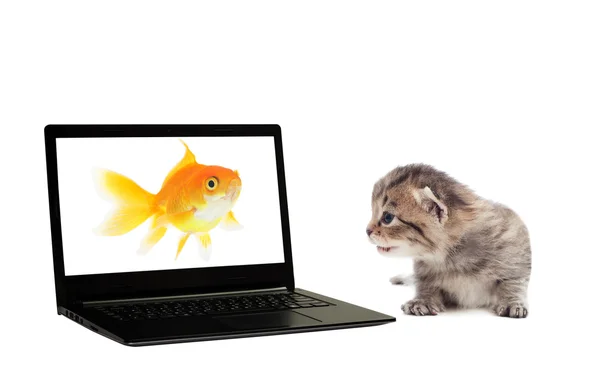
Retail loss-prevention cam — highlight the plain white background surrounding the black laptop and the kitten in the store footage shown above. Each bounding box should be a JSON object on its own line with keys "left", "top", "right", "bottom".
{"left": 0, "top": 0, "right": 600, "bottom": 368}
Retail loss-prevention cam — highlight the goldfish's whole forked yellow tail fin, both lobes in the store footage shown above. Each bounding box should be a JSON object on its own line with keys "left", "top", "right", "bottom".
{"left": 94, "top": 169, "right": 154, "bottom": 236}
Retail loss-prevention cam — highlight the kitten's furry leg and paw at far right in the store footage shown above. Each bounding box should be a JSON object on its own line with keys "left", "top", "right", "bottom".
{"left": 493, "top": 278, "right": 529, "bottom": 318}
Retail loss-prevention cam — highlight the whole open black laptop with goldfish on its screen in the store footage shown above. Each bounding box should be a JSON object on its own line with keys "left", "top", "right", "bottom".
{"left": 45, "top": 125, "right": 395, "bottom": 346}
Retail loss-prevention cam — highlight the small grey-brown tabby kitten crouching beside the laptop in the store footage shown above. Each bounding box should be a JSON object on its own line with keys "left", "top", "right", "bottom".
{"left": 367, "top": 164, "right": 531, "bottom": 318}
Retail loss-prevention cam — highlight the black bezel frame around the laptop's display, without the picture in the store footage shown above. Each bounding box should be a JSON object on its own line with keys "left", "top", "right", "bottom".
{"left": 44, "top": 125, "right": 294, "bottom": 305}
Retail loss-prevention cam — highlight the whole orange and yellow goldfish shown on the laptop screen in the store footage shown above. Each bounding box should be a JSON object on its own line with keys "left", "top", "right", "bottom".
{"left": 95, "top": 140, "right": 242, "bottom": 259}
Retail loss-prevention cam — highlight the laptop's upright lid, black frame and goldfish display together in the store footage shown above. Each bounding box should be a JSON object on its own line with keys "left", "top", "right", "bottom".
{"left": 45, "top": 125, "right": 294, "bottom": 305}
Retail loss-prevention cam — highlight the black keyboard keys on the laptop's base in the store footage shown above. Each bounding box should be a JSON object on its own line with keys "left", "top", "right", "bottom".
{"left": 94, "top": 292, "right": 332, "bottom": 321}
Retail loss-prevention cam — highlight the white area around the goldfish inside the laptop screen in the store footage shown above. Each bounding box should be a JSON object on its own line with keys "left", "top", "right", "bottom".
{"left": 57, "top": 137, "right": 284, "bottom": 275}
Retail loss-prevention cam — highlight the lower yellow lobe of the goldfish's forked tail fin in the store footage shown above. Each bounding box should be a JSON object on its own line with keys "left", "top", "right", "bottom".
{"left": 94, "top": 206, "right": 152, "bottom": 236}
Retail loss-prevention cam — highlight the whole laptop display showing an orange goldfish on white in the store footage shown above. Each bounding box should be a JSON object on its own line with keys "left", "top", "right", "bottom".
{"left": 56, "top": 137, "right": 285, "bottom": 276}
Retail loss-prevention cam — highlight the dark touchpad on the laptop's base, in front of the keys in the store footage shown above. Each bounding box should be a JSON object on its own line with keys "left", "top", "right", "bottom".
{"left": 216, "top": 311, "right": 321, "bottom": 330}
